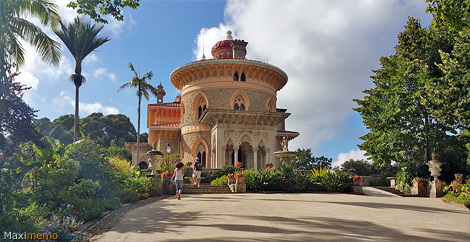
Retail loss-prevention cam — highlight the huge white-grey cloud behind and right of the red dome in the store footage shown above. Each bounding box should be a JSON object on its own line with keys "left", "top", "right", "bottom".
{"left": 194, "top": 0, "right": 430, "bottom": 153}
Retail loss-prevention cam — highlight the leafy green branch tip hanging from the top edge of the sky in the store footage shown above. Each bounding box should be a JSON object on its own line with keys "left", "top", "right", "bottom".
{"left": 67, "top": 0, "right": 139, "bottom": 23}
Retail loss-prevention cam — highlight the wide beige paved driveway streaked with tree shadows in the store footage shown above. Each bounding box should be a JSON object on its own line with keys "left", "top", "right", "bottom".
{"left": 99, "top": 188, "right": 470, "bottom": 242}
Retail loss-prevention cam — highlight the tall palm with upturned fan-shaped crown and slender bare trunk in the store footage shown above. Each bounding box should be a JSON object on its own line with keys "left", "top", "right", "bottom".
{"left": 54, "top": 17, "right": 109, "bottom": 141}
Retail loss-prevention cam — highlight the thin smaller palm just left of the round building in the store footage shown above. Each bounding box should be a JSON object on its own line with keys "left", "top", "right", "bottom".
{"left": 118, "top": 62, "right": 158, "bottom": 164}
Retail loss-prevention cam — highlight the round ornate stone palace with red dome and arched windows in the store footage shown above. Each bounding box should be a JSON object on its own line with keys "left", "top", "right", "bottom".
{"left": 141, "top": 30, "right": 299, "bottom": 170}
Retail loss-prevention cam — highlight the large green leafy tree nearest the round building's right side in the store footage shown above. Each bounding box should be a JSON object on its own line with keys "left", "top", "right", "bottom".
{"left": 354, "top": 18, "right": 455, "bottom": 166}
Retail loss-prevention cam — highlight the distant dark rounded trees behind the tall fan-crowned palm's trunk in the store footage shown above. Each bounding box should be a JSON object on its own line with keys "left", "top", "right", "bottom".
{"left": 34, "top": 113, "right": 136, "bottom": 147}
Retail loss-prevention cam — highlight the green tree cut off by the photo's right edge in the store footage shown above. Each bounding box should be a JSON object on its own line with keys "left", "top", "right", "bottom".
{"left": 423, "top": 0, "right": 470, "bottom": 165}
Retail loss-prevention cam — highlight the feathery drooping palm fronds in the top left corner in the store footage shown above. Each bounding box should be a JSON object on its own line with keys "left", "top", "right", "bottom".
{"left": 0, "top": 0, "right": 60, "bottom": 96}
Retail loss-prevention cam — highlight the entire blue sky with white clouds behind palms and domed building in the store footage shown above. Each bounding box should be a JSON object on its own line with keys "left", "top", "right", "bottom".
{"left": 18, "top": 0, "right": 431, "bottom": 164}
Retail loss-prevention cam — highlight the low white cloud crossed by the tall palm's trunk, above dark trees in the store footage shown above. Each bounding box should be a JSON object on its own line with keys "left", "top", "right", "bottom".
{"left": 52, "top": 92, "right": 119, "bottom": 117}
